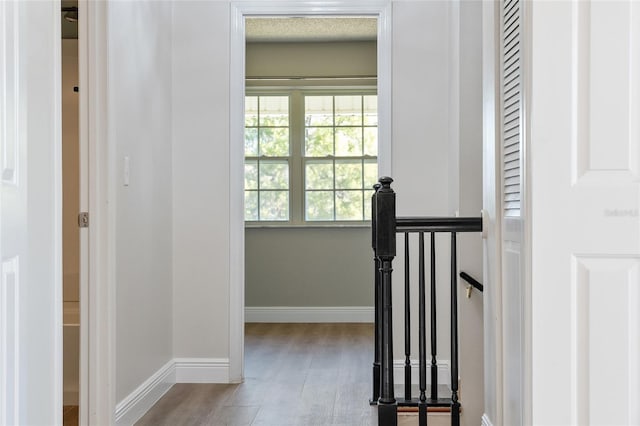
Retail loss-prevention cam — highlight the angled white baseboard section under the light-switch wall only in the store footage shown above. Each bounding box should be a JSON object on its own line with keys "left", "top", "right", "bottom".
{"left": 116, "top": 360, "right": 176, "bottom": 426}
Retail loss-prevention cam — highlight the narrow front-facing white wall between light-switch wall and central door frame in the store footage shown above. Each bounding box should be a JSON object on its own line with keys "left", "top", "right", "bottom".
{"left": 170, "top": 1, "right": 230, "bottom": 358}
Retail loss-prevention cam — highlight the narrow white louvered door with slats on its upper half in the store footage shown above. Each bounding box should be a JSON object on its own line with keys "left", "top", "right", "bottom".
{"left": 498, "top": 0, "right": 526, "bottom": 426}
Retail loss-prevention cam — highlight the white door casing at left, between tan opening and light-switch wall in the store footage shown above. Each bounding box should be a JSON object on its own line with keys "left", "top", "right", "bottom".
{"left": 78, "top": 0, "right": 116, "bottom": 425}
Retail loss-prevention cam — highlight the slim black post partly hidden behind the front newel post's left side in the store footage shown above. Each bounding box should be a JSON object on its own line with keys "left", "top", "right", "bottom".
{"left": 369, "top": 183, "right": 382, "bottom": 405}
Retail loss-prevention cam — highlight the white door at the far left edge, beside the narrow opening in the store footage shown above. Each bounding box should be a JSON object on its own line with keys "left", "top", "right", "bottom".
{"left": 0, "top": 1, "right": 62, "bottom": 425}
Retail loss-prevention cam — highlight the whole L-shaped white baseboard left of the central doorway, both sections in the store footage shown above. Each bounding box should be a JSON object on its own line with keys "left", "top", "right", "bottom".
{"left": 116, "top": 358, "right": 229, "bottom": 426}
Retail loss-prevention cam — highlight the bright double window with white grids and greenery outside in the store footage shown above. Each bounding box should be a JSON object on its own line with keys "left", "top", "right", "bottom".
{"left": 245, "top": 90, "right": 378, "bottom": 224}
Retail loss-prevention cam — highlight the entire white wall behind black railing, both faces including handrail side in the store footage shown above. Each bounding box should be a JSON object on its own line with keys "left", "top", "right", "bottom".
{"left": 392, "top": 6, "right": 483, "bottom": 425}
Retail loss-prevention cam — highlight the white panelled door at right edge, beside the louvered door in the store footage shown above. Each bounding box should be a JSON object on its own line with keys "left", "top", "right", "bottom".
{"left": 529, "top": 0, "right": 640, "bottom": 425}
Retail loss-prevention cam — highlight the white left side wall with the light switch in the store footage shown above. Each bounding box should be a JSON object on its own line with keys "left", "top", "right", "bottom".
{"left": 108, "top": 1, "right": 173, "bottom": 401}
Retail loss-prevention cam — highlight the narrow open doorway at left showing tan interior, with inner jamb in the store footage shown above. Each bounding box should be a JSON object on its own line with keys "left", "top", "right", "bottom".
{"left": 60, "top": 0, "right": 92, "bottom": 425}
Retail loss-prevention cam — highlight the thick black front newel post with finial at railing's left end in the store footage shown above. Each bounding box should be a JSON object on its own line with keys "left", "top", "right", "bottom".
{"left": 375, "top": 177, "right": 398, "bottom": 426}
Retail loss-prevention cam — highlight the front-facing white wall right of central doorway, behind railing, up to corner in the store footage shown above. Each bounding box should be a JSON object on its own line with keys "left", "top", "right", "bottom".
{"left": 392, "top": 1, "right": 451, "bottom": 382}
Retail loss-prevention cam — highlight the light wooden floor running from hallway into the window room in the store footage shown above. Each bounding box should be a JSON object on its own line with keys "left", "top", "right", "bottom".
{"left": 136, "top": 324, "right": 377, "bottom": 426}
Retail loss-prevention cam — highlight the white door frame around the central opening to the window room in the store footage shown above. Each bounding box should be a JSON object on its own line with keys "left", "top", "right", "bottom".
{"left": 229, "top": 0, "right": 392, "bottom": 382}
